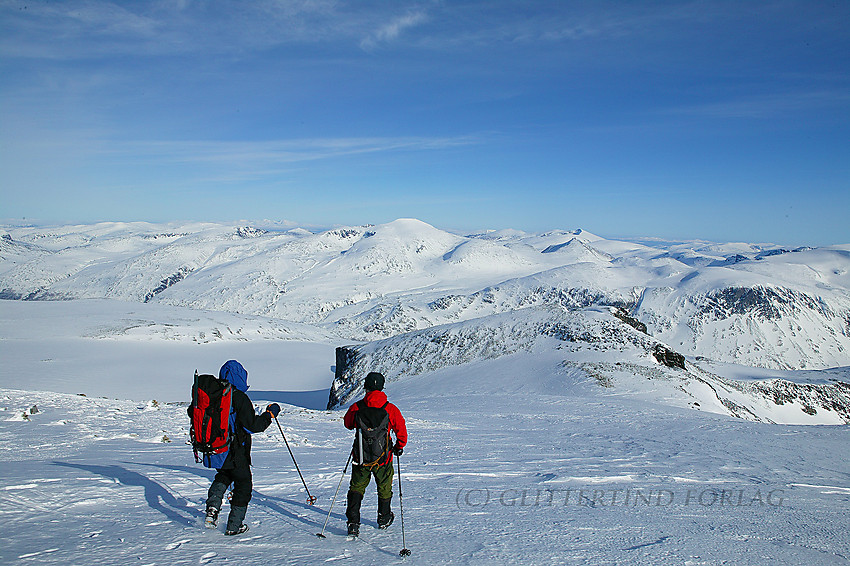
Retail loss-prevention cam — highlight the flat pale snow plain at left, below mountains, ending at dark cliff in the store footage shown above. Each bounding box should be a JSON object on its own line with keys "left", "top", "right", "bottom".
{"left": 0, "top": 299, "right": 334, "bottom": 407}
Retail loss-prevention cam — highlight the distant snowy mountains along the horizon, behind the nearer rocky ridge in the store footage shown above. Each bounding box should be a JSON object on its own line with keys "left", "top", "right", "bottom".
{"left": 0, "top": 219, "right": 850, "bottom": 369}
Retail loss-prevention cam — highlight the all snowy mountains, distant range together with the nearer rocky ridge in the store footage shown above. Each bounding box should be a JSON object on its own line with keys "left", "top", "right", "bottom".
{"left": 0, "top": 219, "right": 850, "bottom": 422}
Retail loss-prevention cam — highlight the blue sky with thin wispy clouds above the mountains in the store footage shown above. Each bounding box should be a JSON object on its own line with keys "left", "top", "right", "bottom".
{"left": 0, "top": 0, "right": 850, "bottom": 245}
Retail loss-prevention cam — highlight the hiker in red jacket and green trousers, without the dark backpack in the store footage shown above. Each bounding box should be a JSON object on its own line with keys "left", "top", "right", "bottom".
{"left": 343, "top": 372, "right": 407, "bottom": 536}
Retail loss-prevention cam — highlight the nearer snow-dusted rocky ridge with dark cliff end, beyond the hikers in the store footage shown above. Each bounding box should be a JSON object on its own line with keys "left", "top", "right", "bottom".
{"left": 328, "top": 307, "right": 850, "bottom": 424}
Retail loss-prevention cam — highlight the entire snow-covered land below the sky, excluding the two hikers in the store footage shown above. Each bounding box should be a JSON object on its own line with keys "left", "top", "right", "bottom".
{"left": 0, "top": 220, "right": 850, "bottom": 566}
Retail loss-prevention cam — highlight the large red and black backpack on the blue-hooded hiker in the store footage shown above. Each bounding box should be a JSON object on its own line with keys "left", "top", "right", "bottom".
{"left": 188, "top": 370, "right": 234, "bottom": 468}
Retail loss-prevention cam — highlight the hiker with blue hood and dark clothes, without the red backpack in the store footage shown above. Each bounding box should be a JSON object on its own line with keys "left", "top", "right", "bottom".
{"left": 205, "top": 360, "right": 280, "bottom": 535}
